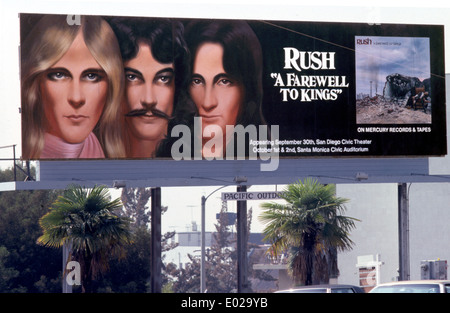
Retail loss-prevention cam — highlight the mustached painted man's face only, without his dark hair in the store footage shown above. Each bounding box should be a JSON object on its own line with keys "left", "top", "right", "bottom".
{"left": 124, "top": 44, "right": 175, "bottom": 156}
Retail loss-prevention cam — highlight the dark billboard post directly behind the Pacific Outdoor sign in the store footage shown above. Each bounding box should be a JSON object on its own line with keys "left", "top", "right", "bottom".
{"left": 237, "top": 186, "right": 249, "bottom": 293}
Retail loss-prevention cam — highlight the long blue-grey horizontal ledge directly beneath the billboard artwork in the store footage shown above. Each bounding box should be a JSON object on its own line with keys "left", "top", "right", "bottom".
{"left": 36, "top": 158, "right": 432, "bottom": 190}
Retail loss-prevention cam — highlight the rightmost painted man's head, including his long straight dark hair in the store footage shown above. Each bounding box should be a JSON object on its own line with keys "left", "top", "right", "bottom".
{"left": 185, "top": 20, "right": 265, "bottom": 157}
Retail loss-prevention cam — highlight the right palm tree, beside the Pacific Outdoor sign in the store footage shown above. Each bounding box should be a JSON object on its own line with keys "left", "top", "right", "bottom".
{"left": 260, "top": 179, "right": 357, "bottom": 285}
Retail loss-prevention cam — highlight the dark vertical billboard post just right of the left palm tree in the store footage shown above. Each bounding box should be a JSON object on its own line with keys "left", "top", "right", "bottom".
{"left": 151, "top": 187, "right": 162, "bottom": 293}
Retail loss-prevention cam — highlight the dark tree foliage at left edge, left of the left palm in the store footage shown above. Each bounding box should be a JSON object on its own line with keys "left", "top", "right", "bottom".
{"left": 0, "top": 168, "right": 62, "bottom": 293}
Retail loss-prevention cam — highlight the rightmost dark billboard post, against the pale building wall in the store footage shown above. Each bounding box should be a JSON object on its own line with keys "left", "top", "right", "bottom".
{"left": 398, "top": 183, "right": 410, "bottom": 280}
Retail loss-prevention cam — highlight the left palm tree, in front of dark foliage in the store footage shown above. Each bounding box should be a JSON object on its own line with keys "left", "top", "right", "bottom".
{"left": 38, "top": 186, "right": 132, "bottom": 292}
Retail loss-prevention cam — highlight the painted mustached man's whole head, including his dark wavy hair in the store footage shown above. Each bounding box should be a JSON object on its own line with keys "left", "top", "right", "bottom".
{"left": 111, "top": 18, "right": 192, "bottom": 158}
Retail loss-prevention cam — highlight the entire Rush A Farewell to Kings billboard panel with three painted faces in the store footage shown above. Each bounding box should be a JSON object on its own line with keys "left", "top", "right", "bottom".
{"left": 20, "top": 14, "right": 447, "bottom": 160}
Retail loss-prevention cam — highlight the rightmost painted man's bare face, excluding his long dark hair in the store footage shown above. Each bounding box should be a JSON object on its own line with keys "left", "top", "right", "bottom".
{"left": 189, "top": 43, "right": 244, "bottom": 149}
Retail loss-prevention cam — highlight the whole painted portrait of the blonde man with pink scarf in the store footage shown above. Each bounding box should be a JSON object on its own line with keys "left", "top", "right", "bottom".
{"left": 21, "top": 14, "right": 125, "bottom": 159}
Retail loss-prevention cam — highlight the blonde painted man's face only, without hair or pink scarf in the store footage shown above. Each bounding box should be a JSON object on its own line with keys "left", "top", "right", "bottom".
{"left": 40, "top": 32, "right": 108, "bottom": 144}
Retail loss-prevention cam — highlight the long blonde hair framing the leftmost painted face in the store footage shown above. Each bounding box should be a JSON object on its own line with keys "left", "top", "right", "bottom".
{"left": 21, "top": 15, "right": 125, "bottom": 159}
